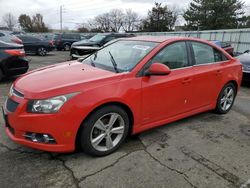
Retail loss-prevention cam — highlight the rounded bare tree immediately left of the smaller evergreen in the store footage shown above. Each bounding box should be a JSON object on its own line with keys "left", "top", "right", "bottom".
{"left": 122, "top": 9, "right": 140, "bottom": 32}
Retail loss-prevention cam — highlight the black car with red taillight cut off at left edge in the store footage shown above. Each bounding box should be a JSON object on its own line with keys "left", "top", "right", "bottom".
{"left": 0, "top": 41, "right": 29, "bottom": 80}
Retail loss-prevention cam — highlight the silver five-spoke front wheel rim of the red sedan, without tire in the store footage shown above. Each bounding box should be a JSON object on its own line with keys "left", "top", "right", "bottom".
{"left": 90, "top": 113, "right": 125, "bottom": 151}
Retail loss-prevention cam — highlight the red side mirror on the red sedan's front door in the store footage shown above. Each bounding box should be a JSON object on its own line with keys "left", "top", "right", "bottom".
{"left": 145, "top": 63, "right": 171, "bottom": 76}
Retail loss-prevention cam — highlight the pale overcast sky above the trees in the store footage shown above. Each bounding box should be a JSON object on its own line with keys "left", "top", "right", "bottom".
{"left": 0, "top": 0, "right": 250, "bottom": 29}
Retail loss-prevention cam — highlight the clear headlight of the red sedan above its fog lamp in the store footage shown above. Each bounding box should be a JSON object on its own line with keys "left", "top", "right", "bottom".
{"left": 27, "top": 93, "right": 77, "bottom": 114}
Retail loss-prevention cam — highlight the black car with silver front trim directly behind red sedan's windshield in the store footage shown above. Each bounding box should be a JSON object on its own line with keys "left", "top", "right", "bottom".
{"left": 70, "top": 33, "right": 135, "bottom": 59}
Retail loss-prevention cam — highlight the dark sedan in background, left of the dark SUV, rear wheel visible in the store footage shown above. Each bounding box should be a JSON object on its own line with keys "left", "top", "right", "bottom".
{"left": 18, "top": 35, "right": 55, "bottom": 56}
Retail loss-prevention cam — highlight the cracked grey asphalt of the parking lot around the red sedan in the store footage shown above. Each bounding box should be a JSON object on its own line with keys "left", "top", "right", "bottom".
{"left": 0, "top": 51, "right": 250, "bottom": 188}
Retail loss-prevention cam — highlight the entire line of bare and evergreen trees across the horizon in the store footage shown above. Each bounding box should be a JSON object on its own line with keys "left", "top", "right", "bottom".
{"left": 2, "top": 0, "right": 250, "bottom": 32}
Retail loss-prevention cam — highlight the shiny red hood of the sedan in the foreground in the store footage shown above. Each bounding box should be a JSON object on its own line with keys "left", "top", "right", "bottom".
{"left": 14, "top": 61, "right": 123, "bottom": 99}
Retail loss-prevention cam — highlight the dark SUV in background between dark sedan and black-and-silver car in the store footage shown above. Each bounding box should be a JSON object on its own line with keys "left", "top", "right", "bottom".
{"left": 53, "top": 33, "right": 85, "bottom": 51}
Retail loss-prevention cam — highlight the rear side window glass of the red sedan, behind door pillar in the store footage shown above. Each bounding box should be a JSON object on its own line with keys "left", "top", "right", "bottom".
{"left": 191, "top": 42, "right": 227, "bottom": 65}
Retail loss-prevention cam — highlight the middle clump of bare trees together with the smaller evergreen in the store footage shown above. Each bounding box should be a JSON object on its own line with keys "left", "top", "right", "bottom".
{"left": 78, "top": 3, "right": 178, "bottom": 32}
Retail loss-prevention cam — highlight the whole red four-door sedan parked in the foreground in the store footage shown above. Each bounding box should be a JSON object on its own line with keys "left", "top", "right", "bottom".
{"left": 3, "top": 36, "right": 242, "bottom": 156}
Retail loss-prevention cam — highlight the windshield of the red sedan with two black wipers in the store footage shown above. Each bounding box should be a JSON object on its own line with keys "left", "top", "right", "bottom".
{"left": 82, "top": 41, "right": 158, "bottom": 72}
